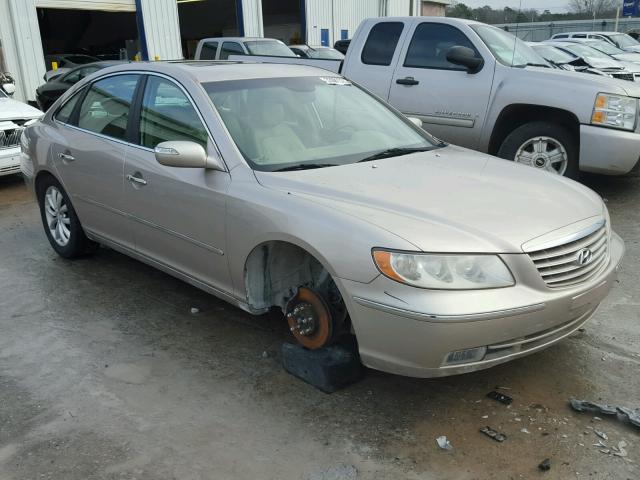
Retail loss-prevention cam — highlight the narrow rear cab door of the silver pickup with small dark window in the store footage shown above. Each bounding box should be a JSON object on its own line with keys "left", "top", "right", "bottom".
{"left": 344, "top": 20, "right": 407, "bottom": 100}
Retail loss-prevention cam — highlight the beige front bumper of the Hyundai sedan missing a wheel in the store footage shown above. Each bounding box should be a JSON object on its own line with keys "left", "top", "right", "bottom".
{"left": 338, "top": 233, "right": 624, "bottom": 377}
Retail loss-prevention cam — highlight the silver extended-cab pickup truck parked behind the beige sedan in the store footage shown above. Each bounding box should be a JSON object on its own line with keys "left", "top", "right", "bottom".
{"left": 216, "top": 17, "right": 640, "bottom": 178}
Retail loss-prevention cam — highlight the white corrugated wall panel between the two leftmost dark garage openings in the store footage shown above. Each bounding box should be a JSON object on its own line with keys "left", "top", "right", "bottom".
{"left": 138, "top": 0, "right": 182, "bottom": 60}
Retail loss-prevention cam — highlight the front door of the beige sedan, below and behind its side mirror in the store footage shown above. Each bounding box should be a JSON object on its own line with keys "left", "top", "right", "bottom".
{"left": 124, "top": 75, "right": 232, "bottom": 291}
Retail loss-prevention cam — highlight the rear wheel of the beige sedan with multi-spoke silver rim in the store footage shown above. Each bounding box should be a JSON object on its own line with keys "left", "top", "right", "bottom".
{"left": 37, "top": 177, "right": 98, "bottom": 258}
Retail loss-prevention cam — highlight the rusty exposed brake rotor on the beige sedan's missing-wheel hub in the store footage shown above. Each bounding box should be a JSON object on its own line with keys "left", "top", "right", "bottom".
{"left": 286, "top": 287, "right": 333, "bottom": 350}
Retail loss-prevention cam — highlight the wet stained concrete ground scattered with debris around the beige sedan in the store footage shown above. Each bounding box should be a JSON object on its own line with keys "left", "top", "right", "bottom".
{"left": 0, "top": 173, "right": 640, "bottom": 480}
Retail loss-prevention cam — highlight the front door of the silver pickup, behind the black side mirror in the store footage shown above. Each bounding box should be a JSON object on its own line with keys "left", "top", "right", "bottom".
{"left": 389, "top": 21, "right": 495, "bottom": 149}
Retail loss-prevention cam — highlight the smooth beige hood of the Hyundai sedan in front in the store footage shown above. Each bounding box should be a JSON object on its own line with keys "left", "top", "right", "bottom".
{"left": 255, "top": 146, "right": 603, "bottom": 253}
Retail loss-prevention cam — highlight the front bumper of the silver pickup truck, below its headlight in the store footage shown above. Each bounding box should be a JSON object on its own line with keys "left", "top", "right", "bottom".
{"left": 580, "top": 125, "right": 640, "bottom": 175}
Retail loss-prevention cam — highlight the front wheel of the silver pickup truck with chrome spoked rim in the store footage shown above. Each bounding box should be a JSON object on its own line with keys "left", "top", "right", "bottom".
{"left": 498, "top": 122, "right": 579, "bottom": 179}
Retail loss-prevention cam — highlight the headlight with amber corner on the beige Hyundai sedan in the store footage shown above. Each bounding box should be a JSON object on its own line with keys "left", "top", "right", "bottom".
{"left": 373, "top": 249, "right": 515, "bottom": 290}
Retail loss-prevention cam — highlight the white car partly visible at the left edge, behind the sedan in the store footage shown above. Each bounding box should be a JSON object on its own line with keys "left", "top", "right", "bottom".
{"left": 0, "top": 89, "right": 44, "bottom": 176}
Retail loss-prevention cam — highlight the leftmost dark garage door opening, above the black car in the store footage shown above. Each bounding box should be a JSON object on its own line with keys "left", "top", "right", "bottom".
{"left": 37, "top": 8, "right": 139, "bottom": 70}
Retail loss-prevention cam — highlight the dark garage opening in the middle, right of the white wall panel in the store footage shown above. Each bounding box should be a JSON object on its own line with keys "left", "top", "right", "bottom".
{"left": 178, "top": 0, "right": 240, "bottom": 58}
